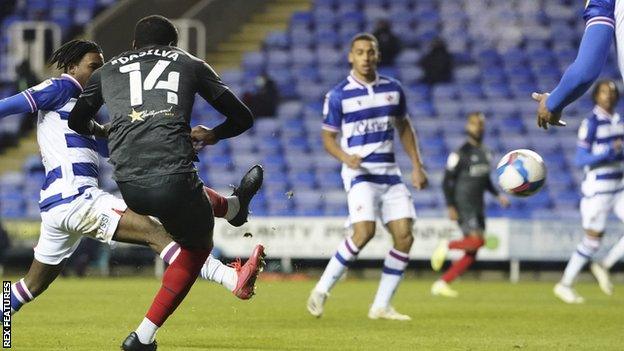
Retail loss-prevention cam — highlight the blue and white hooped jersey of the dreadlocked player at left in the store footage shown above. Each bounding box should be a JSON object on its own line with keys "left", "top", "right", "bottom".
{"left": 22, "top": 74, "right": 99, "bottom": 211}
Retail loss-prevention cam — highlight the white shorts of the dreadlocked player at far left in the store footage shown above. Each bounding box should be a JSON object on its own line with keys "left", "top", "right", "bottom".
{"left": 35, "top": 187, "right": 128, "bottom": 265}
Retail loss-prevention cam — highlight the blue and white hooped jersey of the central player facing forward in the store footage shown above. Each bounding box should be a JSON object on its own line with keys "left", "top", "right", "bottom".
{"left": 323, "top": 73, "right": 409, "bottom": 191}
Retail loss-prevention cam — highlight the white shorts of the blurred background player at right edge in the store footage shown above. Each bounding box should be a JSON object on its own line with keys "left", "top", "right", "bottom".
{"left": 581, "top": 191, "right": 624, "bottom": 233}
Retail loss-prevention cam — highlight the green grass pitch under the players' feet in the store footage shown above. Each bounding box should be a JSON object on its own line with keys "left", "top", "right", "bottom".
{"left": 8, "top": 278, "right": 624, "bottom": 351}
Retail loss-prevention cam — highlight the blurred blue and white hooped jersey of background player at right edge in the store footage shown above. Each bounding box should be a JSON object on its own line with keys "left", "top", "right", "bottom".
{"left": 578, "top": 106, "right": 624, "bottom": 196}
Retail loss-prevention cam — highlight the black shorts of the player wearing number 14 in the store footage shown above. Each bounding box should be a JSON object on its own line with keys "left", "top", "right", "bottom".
{"left": 117, "top": 172, "right": 214, "bottom": 249}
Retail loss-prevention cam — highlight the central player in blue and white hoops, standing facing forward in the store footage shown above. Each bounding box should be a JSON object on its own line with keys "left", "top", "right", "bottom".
{"left": 307, "top": 33, "right": 427, "bottom": 320}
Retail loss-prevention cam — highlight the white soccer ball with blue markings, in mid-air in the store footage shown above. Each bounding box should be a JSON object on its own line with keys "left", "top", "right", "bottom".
{"left": 496, "top": 149, "right": 546, "bottom": 197}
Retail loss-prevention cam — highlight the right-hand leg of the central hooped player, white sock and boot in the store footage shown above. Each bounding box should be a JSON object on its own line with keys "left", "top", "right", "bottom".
{"left": 368, "top": 218, "right": 414, "bottom": 321}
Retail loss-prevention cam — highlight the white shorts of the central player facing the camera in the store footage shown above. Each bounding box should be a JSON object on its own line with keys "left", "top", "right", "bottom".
{"left": 347, "top": 182, "right": 416, "bottom": 224}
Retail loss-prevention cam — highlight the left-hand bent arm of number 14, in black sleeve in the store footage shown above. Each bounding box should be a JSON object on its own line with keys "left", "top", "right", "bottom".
{"left": 67, "top": 69, "right": 110, "bottom": 138}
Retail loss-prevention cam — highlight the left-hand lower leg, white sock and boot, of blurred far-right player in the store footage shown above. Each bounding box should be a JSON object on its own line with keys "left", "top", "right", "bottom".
{"left": 553, "top": 231, "right": 601, "bottom": 303}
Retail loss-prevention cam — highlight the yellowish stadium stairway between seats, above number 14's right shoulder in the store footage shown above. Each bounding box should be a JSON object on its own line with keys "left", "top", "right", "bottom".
{"left": 207, "top": 0, "right": 311, "bottom": 72}
